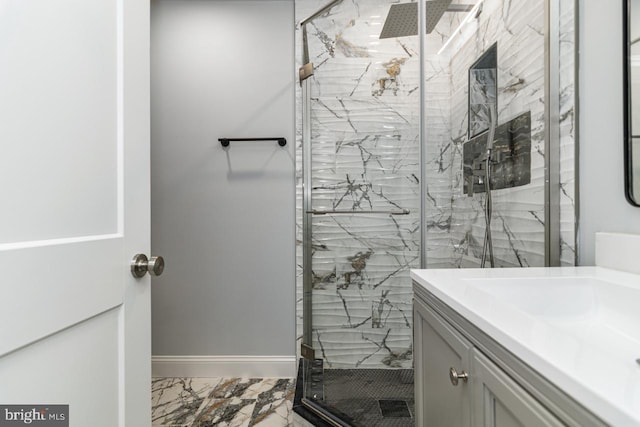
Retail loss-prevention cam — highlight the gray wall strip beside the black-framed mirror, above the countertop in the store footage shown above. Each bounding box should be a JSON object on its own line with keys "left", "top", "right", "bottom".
{"left": 578, "top": 0, "right": 640, "bottom": 265}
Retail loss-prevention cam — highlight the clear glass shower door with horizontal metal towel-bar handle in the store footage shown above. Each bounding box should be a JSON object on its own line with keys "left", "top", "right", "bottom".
{"left": 302, "top": 1, "right": 420, "bottom": 425}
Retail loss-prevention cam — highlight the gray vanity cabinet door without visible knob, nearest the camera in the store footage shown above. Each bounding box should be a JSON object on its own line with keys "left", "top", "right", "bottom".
{"left": 472, "top": 350, "right": 564, "bottom": 427}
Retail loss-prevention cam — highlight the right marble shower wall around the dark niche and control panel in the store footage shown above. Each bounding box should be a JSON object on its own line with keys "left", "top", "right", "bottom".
{"left": 424, "top": 0, "right": 575, "bottom": 268}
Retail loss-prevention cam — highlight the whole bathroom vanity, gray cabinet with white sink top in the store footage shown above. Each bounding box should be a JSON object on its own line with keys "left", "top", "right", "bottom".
{"left": 411, "top": 236, "right": 640, "bottom": 427}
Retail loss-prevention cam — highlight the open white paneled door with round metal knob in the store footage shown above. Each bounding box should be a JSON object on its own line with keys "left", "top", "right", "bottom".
{"left": 0, "top": 0, "right": 151, "bottom": 427}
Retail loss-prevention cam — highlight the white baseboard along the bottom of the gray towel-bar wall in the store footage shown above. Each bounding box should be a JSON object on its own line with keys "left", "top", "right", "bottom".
{"left": 151, "top": 356, "right": 297, "bottom": 378}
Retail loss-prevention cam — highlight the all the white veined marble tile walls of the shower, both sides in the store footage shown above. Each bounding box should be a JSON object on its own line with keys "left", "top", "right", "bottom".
{"left": 296, "top": 0, "right": 575, "bottom": 368}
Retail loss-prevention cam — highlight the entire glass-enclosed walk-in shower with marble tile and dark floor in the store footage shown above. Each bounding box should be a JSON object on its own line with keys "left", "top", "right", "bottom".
{"left": 297, "top": 0, "right": 573, "bottom": 426}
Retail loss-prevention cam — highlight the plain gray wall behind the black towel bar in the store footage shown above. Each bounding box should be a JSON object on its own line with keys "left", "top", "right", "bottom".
{"left": 151, "top": 0, "right": 295, "bottom": 356}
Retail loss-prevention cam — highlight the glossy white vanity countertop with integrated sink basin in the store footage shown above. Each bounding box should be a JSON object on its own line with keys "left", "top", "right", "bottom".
{"left": 411, "top": 267, "right": 640, "bottom": 426}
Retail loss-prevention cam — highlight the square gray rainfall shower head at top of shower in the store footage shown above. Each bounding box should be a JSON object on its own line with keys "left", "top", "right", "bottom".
{"left": 380, "top": 0, "right": 473, "bottom": 39}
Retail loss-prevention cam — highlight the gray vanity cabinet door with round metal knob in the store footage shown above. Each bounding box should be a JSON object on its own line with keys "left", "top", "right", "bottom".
{"left": 414, "top": 300, "right": 472, "bottom": 427}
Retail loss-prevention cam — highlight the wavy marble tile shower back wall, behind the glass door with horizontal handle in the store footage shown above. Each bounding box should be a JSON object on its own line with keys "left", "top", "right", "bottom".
{"left": 296, "top": 0, "right": 420, "bottom": 368}
